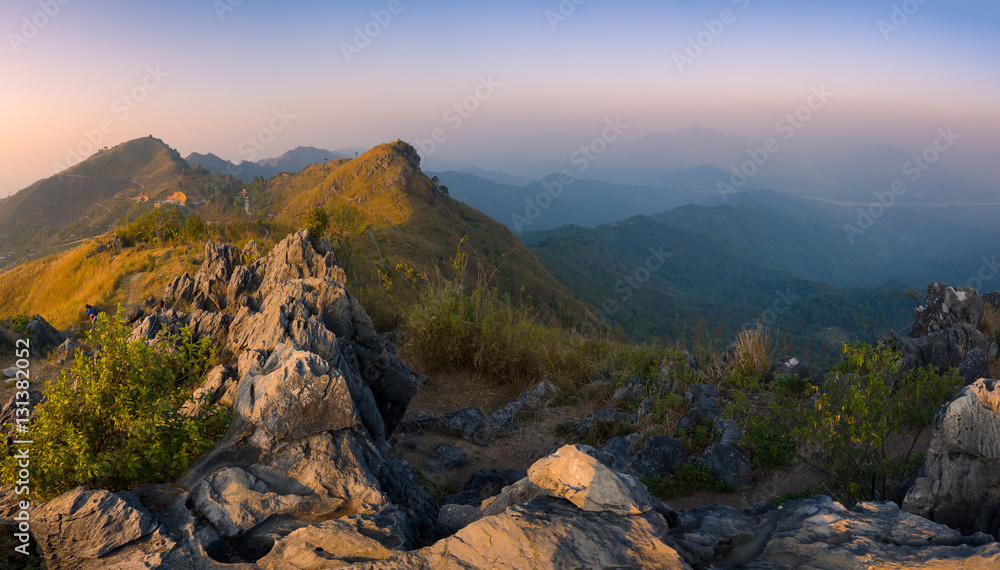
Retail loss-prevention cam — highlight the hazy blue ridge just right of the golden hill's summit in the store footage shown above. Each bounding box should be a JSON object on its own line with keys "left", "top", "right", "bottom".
{"left": 432, "top": 172, "right": 717, "bottom": 233}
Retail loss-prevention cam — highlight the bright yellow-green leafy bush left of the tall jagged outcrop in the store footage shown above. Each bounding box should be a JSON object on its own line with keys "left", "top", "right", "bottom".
{"left": 0, "top": 310, "right": 229, "bottom": 500}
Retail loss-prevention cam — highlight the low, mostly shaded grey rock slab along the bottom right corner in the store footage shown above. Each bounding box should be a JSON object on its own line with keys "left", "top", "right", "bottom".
{"left": 664, "top": 496, "right": 1000, "bottom": 569}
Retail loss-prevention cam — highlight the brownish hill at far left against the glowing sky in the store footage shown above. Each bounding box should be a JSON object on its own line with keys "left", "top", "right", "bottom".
{"left": 0, "top": 137, "right": 224, "bottom": 252}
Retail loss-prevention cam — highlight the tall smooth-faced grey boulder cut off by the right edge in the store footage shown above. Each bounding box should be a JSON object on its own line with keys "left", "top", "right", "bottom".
{"left": 903, "top": 379, "right": 1000, "bottom": 536}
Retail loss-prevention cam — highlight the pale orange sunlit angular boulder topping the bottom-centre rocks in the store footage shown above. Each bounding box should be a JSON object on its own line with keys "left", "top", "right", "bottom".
{"left": 528, "top": 445, "right": 663, "bottom": 515}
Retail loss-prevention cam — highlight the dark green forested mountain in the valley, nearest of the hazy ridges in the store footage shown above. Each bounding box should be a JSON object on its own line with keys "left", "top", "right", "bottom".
{"left": 525, "top": 216, "right": 913, "bottom": 362}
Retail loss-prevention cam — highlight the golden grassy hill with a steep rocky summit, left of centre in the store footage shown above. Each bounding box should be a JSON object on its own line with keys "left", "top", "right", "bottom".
{"left": 264, "top": 141, "right": 593, "bottom": 326}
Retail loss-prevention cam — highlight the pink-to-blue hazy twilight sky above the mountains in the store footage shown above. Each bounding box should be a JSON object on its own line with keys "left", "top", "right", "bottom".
{"left": 0, "top": 0, "right": 1000, "bottom": 196}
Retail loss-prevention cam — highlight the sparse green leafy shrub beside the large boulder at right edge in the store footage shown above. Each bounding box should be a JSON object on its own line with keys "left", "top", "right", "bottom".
{"left": 796, "top": 344, "right": 962, "bottom": 505}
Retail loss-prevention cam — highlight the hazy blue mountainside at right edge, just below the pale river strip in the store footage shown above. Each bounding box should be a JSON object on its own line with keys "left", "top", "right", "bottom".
{"left": 652, "top": 191, "right": 1000, "bottom": 288}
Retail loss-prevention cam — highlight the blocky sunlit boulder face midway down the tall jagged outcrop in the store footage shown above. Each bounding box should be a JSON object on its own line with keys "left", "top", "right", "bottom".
{"left": 234, "top": 344, "right": 362, "bottom": 448}
